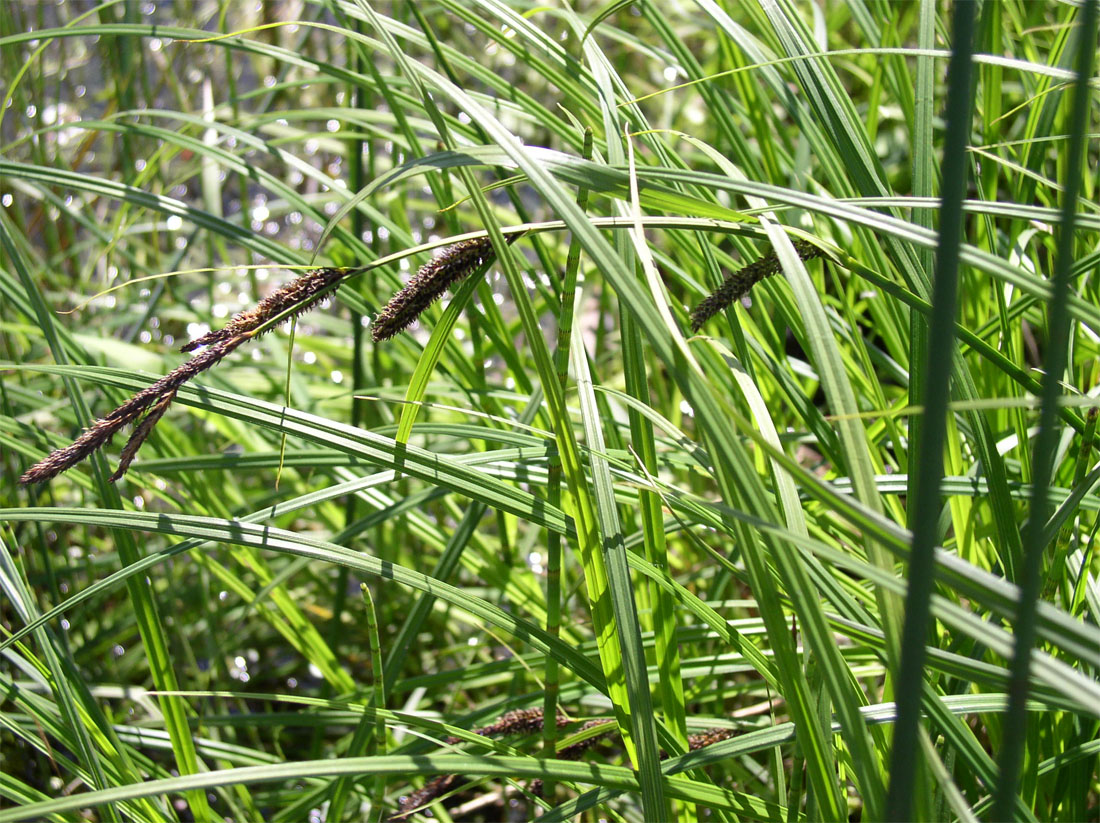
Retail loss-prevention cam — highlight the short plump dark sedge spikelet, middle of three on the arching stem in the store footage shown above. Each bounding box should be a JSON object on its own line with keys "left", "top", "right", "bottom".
{"left": 371, "top": 235, "right": 499, "bottom": 343}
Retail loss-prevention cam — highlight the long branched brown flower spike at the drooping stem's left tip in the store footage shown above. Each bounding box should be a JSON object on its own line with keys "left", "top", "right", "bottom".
{"left": 19, "top": 268, "right": 347, "bottom": 485}
